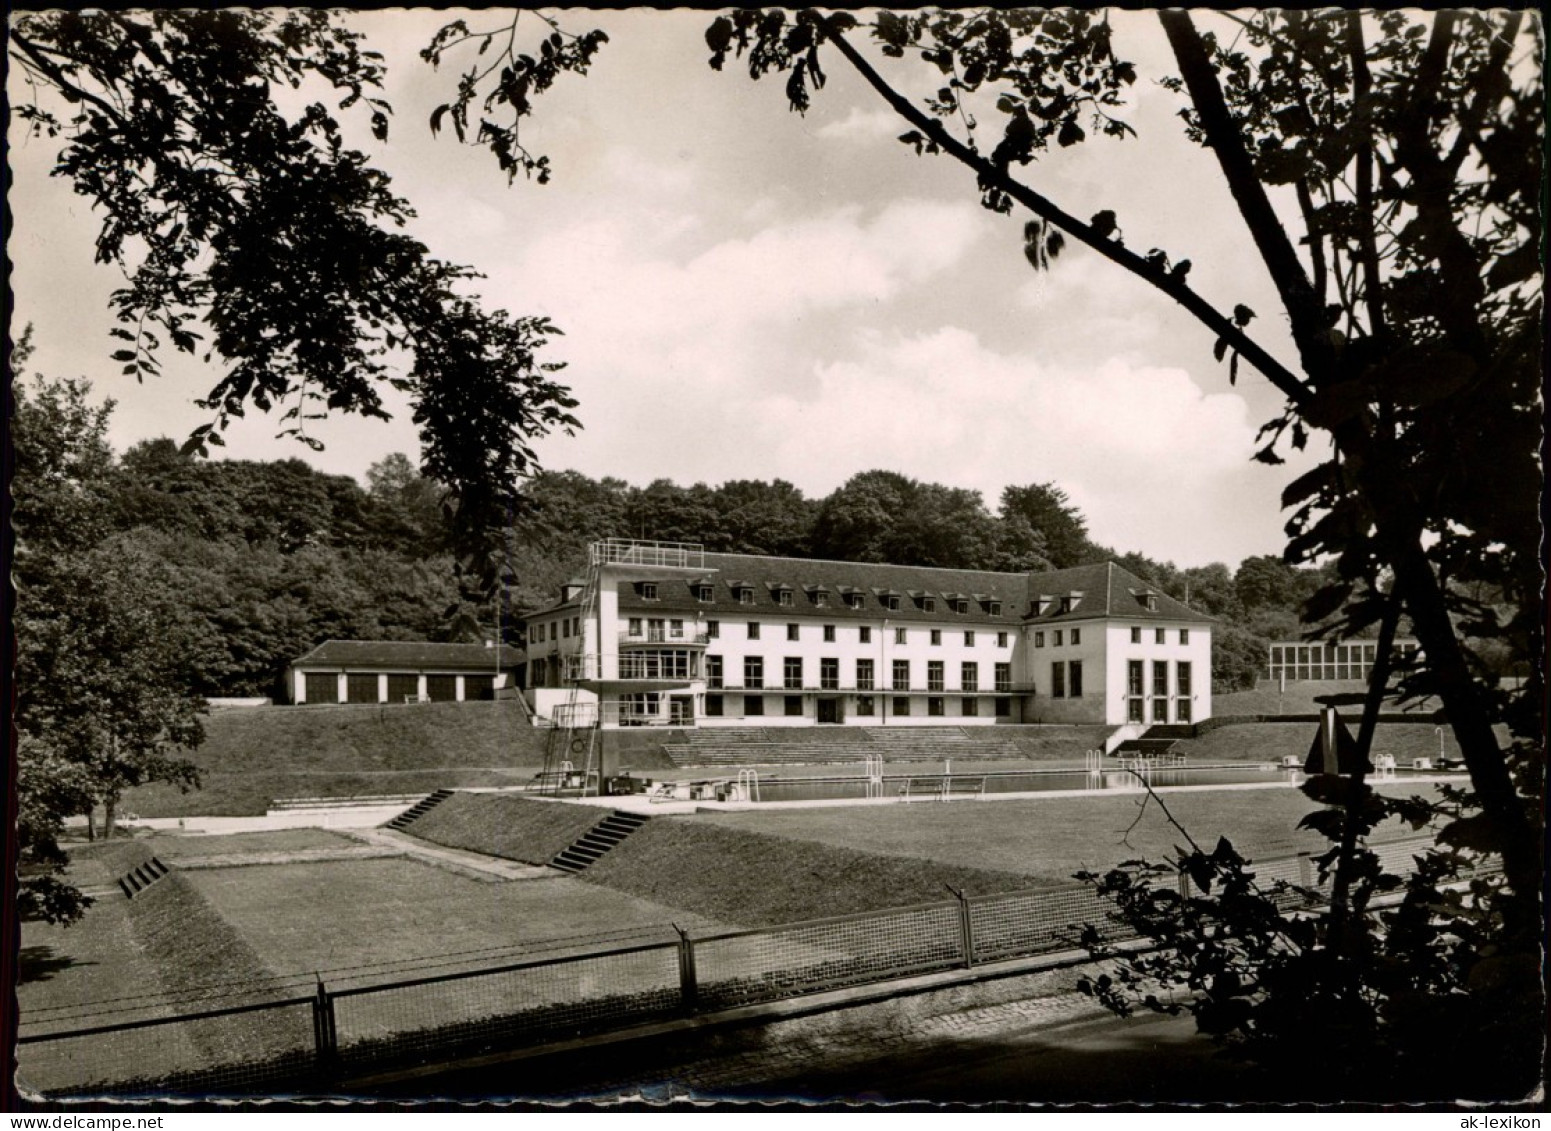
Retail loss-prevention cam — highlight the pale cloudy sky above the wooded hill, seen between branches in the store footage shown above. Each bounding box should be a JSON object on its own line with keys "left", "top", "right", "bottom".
{"left": 8, "top": 9, "right": 1321, "bottom": 566}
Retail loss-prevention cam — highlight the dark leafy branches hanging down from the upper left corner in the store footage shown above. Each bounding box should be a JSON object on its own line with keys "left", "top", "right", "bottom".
{"left": 8, "top": 9, "right": 583, "bottom": 552}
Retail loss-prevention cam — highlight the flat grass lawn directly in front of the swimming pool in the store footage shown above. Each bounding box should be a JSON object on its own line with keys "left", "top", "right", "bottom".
{"left": 691, "top": 782, "right": 1432, "bottom": 903}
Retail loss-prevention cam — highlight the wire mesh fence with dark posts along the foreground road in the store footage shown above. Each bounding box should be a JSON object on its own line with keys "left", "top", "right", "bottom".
{"left": 17, "top": 836, "right": 1494, "bottom": 1095}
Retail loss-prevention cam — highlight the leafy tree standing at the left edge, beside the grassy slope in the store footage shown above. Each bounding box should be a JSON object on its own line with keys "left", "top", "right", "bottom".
{"left": 11, "top": 372, "right": 203, "bottom": 923}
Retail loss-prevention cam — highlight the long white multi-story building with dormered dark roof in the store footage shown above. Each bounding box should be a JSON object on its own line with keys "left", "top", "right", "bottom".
{"left": 524, "top": 540, "right": 1213, "bottom": 726}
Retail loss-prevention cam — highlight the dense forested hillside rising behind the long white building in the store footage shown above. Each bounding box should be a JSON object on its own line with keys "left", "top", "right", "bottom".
{"left": 14, "top": 372, "right": 1352, "bottom": 707}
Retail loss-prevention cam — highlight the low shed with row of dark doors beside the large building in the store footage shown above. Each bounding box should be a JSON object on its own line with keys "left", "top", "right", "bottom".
{"left": 285, "top": 641, "right": 521, "bottom": 704}
